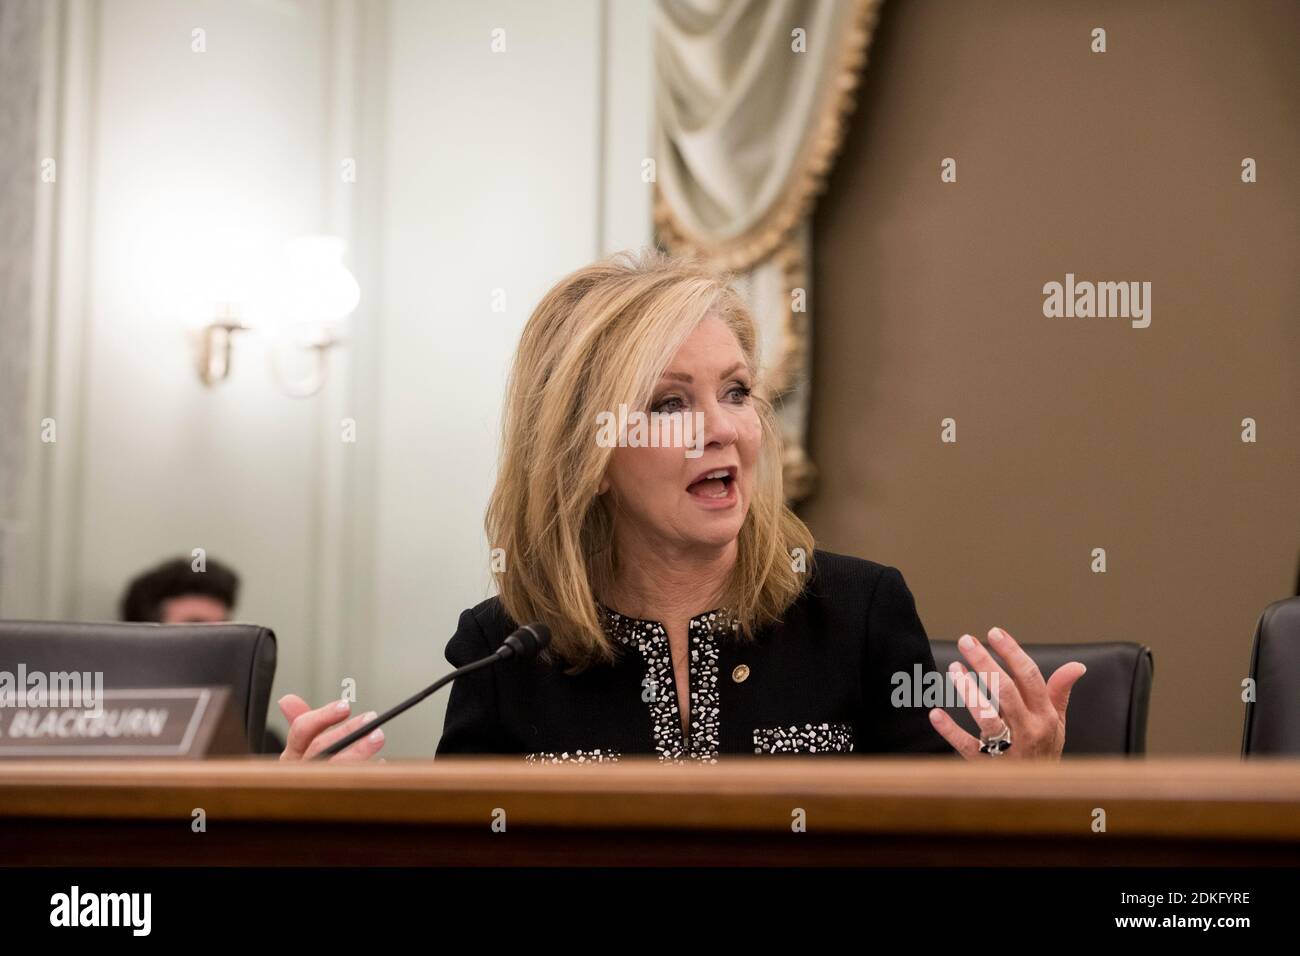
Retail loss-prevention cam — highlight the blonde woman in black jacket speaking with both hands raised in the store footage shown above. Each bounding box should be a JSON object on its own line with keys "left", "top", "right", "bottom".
{"left": 281, "top": 252, "right": 1084, "bottom": 762}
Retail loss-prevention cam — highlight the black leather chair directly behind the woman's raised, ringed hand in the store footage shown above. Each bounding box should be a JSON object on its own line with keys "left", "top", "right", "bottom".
{"left": 930, "top": 641, "right": 1154, "bottom": 756}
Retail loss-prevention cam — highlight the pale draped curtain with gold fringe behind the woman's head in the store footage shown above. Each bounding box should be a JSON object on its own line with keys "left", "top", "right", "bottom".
{"left": 654, "top": 0, "right": 880, "bottom": 501}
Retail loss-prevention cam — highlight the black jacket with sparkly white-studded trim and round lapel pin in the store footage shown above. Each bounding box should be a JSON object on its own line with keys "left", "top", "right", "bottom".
{"left": 438, "top": 551, "right": 953, "bottom": 762}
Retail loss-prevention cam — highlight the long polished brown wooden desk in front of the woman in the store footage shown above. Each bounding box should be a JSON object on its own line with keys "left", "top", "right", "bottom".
{"left": 0, "top": 758, "right": 1300, "bottom": 866}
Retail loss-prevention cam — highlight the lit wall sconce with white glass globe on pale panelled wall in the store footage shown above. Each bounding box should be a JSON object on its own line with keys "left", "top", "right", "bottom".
{"left": 199, "top": 235, "right": 361, "bottom": 398}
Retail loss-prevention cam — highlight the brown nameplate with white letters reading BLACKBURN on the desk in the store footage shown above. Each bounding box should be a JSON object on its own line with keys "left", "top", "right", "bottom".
{"left": 0, "top": 687, "right": 248, "bottom": 758}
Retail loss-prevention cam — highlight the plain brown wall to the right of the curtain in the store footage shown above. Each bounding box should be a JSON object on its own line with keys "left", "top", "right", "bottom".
{"left": 802, "top": 0, "right": 1300, "bottom": 753}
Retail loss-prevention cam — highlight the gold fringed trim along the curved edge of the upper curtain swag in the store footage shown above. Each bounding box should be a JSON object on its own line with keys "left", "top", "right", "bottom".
{"left": 654, "top": 0, "right": 881, "bottom": 272}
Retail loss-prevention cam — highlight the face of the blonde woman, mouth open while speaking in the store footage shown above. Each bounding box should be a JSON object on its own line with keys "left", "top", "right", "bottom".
{"left": 601, "top": 317, "right": 762, "bottom": 550}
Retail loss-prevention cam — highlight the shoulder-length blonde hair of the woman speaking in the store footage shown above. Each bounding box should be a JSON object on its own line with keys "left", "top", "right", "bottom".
{"left": 485, "top": 250, "right": 813, "bottom": 670}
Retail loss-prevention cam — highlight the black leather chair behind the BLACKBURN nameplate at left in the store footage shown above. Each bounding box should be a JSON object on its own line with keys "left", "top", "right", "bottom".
{"left": 0, "top": 620, "right": 276, "bottom": 753}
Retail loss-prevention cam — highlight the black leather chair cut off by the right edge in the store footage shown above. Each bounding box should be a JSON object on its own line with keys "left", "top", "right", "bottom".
{"left": 1242, "top": 597, "right": 1300, "bottom": 757}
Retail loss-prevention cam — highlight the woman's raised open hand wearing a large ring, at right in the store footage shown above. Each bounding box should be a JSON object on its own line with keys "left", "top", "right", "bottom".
{"left": 930, "top": 627, "right": 1088, "bottom": 760}
